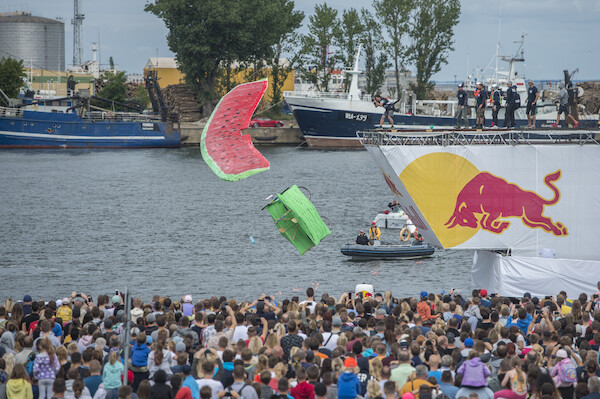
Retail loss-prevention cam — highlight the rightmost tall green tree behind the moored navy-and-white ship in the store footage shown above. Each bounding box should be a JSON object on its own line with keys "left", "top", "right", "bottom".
{"left": 408, "top": 0, "right": 460, "bottom": 99}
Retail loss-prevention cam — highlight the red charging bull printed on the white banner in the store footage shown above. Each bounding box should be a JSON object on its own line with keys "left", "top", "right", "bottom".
{"left": 445, "top": 170, "right": 568, "bottom": 236}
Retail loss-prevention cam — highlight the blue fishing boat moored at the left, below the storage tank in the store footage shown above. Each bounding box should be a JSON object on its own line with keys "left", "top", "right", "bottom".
{"left": 0, "top": 74, "right": 181, "bottom": 148}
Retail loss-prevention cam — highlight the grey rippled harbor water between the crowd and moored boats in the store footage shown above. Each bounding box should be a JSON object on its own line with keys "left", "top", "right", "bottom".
{"left": 0, "top": 147, "right": 473, "bottom": 300}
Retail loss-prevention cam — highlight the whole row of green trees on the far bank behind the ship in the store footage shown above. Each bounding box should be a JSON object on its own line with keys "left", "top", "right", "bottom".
{"left": 145, "top": 0, "right": 460, "bottom": 116}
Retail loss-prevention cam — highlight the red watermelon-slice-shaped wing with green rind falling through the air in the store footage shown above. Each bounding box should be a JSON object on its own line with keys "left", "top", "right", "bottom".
{"left": 200, "top": 79, "right": 270, "bottom": 181}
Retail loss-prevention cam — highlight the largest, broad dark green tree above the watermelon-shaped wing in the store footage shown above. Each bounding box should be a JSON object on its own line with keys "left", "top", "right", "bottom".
{"left": 145, "top": 0, "right": 304, "bottom": 116}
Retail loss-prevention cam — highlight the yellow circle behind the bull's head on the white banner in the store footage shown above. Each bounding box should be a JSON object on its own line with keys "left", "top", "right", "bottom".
{"left": 399, "top": 152, "right": 479, "bottom": 248}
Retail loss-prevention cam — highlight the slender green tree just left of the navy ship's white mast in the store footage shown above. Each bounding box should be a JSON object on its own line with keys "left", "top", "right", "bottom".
{"left": 299, "top": 3, "right": 339, "bottom": 91}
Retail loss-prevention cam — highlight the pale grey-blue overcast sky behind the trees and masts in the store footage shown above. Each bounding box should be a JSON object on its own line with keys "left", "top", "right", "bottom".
{"left": 17, "top": 0, "right": 600, "bottom": 81}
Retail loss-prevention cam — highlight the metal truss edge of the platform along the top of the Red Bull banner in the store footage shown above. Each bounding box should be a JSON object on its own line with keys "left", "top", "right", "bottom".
{"left": 356, "top": 129, "right": 600, "bottom": 146}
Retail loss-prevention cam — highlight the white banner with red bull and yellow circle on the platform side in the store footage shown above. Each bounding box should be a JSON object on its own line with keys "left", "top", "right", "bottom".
{"left": 366, "top": 144, "right": 600, "bottom": 260}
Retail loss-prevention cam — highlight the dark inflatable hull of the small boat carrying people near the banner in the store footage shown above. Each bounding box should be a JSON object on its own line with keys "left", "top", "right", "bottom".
{"left": 341, "top": 242, "right": 435, "bottom": 260}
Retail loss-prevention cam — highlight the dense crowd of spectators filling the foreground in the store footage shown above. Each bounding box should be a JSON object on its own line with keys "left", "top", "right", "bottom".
{"left": 0, "top": 283, "right": 600, "bottom": 399}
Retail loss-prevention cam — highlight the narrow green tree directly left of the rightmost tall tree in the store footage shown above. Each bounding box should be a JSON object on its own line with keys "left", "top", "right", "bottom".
{"left": 373, "top": 0, "right": 412, "bottom": 97}
